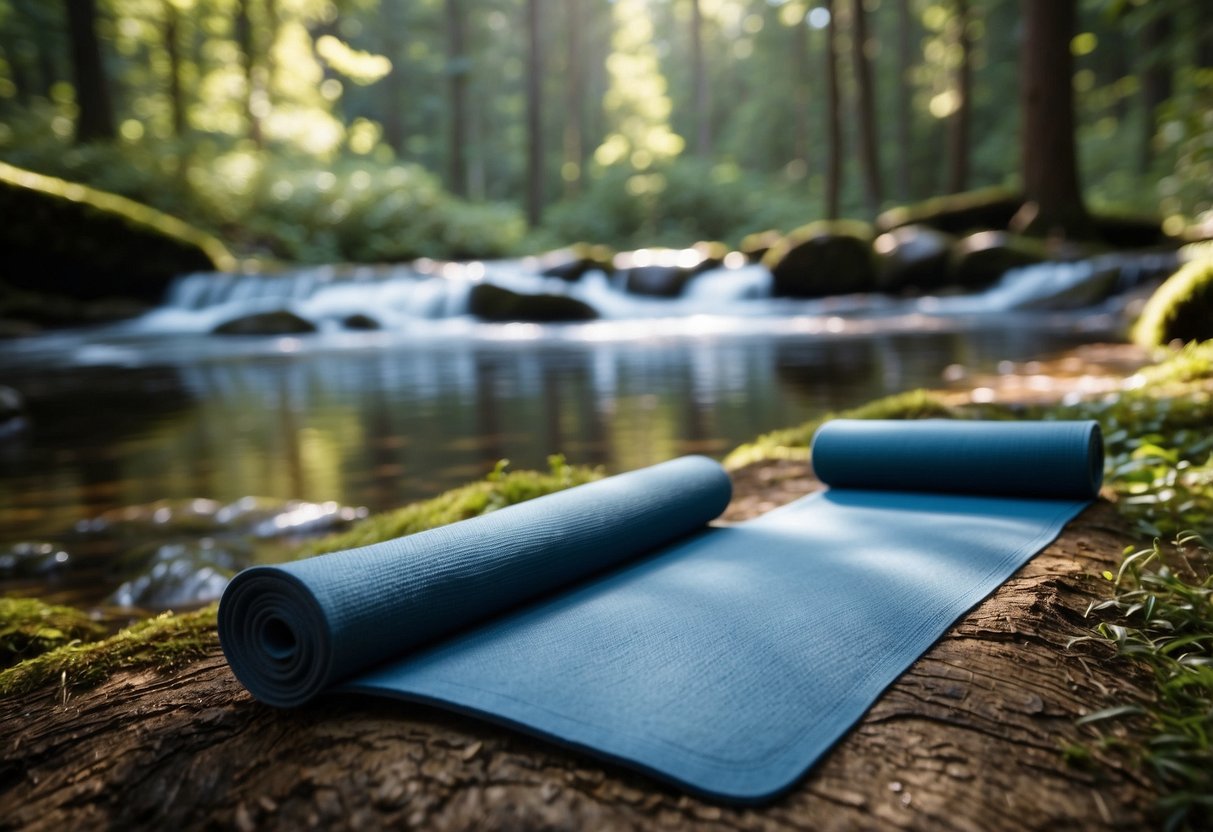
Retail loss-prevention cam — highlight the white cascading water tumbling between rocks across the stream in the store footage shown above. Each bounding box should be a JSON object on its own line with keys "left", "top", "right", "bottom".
{"left": 130, "top": 252, "right": 1175, "bottom": 332}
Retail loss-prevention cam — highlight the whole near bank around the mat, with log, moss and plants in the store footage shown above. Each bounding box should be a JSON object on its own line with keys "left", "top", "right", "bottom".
{"left": 0, "top": 344, "right": 1213, "bottom": 828}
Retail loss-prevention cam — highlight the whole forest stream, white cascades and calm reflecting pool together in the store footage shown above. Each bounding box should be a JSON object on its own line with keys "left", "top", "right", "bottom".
{"left": 0, "top": 251, "right": 1174, "bottom": 605}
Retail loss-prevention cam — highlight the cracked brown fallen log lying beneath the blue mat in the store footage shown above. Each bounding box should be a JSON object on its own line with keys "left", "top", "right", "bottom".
{"left": 0, "top": 462, "right": 1151, "bottom": 831}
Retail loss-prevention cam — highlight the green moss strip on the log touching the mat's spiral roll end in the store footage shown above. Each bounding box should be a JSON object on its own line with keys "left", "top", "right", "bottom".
{"left": 0, "top": 604, "right": 218, "bottom": 699}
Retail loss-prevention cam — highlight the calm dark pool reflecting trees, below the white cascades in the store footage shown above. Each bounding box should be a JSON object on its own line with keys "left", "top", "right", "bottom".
{"left": 0, "top": 327, "right": 1101, "bottom": 553}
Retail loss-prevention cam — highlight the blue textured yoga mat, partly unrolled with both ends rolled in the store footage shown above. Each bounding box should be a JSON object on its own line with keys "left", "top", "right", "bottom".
{"left": 218, "top": 420, "right": 1103, "bottom": 802}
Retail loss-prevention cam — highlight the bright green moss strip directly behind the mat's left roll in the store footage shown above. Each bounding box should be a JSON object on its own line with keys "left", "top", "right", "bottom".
{"left": 298, "top": 455, "right": 603, "bottom": 557}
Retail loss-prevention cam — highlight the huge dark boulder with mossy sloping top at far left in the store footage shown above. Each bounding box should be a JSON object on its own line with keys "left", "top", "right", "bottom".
{"left": 0, "top": 163, "right": 235, "bottom": 302}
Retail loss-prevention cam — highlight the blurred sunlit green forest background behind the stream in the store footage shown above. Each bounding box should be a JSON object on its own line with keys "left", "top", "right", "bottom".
{"left": 0, "top": 0, "right": 1213, "bottom": 262}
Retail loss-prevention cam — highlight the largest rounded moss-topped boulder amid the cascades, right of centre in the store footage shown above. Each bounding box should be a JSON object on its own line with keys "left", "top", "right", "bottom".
{"left": 763, "top": 220, "right": 876, "bottom": 297}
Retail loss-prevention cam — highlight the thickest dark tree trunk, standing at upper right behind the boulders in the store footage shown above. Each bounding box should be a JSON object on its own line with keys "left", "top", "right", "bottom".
{"left": 1012, "top": 0, "right": 1090, "bottom": 238}
